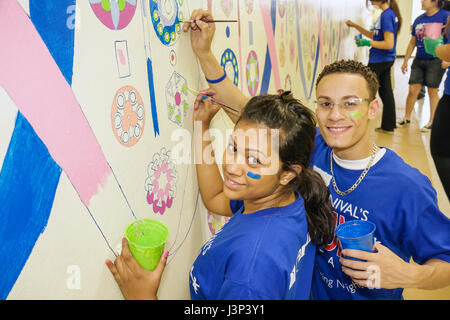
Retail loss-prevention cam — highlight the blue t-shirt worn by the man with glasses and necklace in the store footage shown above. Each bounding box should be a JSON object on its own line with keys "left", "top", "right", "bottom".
{"left": 312, "top": 134, "right": 450, "bottom": 300}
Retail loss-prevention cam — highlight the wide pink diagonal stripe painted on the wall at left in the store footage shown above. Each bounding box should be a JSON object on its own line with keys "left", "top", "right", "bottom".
{"left": 0, "top": 0, "right": 111, "bottom": 205}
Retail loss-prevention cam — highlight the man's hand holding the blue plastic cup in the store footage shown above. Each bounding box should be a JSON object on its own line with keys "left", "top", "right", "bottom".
{"left": 339, "top": 242, "right": 414, "bottom": 289}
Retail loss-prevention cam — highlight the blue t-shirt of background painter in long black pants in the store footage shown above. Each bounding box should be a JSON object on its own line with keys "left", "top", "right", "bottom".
{"left": 369, "top": 8, "right": 398, "bottom": 63}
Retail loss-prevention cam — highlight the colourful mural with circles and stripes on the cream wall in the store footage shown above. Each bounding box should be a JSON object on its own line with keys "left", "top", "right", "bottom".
{"left": 0, "top": 0, "right": 366, "bottom": 299}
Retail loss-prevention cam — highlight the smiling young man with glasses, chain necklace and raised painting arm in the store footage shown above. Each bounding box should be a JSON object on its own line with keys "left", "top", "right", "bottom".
{"left": 184, "top": 10, "right": 450, "bottom": 299}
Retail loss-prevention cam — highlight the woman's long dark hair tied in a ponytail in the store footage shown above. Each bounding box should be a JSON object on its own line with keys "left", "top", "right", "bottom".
{"left": 237, "top": 91, "right": 334, "bottom": 246}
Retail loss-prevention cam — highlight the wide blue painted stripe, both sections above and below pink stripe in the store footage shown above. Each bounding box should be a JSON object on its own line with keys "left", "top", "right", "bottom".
{"left": 0, "top": 0, "right": 75, "bottom": 299}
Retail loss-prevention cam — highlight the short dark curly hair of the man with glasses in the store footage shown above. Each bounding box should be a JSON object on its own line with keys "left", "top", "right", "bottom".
{"left": 316, "top": 60, "right": 380, "bottom": 99}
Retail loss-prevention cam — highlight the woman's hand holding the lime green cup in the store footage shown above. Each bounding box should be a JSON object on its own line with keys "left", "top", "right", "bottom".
{"left": 106, "top": 238, "right": 168, "bottom": 300}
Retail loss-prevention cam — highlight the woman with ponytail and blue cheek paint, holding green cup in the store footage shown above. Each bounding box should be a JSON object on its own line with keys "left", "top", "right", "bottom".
{"left": 106, "top": 92, "right": 334, "bottom": 300}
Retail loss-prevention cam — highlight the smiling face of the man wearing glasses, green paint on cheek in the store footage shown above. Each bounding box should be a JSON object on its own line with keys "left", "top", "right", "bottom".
{"left": 316, "top": 73, "right": 378, "bottom": 160}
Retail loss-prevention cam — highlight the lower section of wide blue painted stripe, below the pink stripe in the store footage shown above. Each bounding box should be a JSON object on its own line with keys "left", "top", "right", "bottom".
{"left": 0, "top": 113, "right": 61, "bottom": 299}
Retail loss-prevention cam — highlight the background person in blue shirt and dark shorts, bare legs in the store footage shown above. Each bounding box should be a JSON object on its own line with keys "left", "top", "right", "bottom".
{"left": 398, "top": 0, "right": 449, "bottom": 131}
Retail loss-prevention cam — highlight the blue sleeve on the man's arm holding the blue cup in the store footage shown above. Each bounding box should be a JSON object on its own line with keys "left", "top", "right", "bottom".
{"left": 405, "top": 177, "right": 450, "bottom": 264}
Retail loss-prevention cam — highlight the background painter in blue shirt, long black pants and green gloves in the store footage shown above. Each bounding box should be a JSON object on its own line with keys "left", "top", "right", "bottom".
{"left": 346, "top": 0, "right": 402, "bottom": 134}
